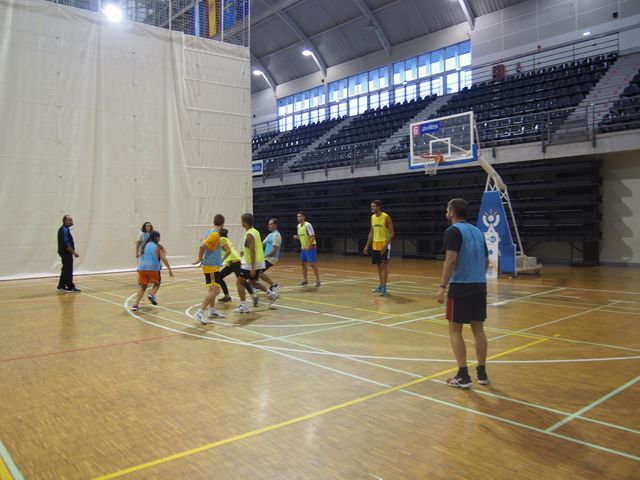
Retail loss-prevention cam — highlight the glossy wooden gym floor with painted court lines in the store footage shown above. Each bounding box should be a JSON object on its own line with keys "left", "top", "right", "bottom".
{"left": 0, "top": 255, "right": 640, "bottom": 480}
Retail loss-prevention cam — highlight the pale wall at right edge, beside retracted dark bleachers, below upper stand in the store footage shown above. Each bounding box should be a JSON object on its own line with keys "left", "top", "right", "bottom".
{"left": 600, "top": 151, "right": 640, "bottom": 266}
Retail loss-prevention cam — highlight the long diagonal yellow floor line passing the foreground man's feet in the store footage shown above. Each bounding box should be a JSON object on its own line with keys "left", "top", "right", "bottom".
{"left": 95, "top": 338, "right": 548, "bottom": 480}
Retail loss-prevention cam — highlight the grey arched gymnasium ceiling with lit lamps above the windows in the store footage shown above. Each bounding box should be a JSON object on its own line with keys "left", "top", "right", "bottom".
{"left": 251, "top": 0, "right": 526, "bottom": 92}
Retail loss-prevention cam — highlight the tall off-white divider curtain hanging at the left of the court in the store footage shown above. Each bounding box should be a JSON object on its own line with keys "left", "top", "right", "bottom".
{"left": 0, "top": 0, "right": 252, "bottom": 279}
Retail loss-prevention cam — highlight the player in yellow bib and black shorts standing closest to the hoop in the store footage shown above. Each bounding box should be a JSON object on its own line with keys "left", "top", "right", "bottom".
{"left": 362, "top": 200, "right": 395, "bottom": 297}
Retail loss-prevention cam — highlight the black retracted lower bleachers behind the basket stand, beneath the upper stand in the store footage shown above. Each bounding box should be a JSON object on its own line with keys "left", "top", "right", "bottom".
{"left": 254, "top": 159, "right": 602, "bottom": 257}
